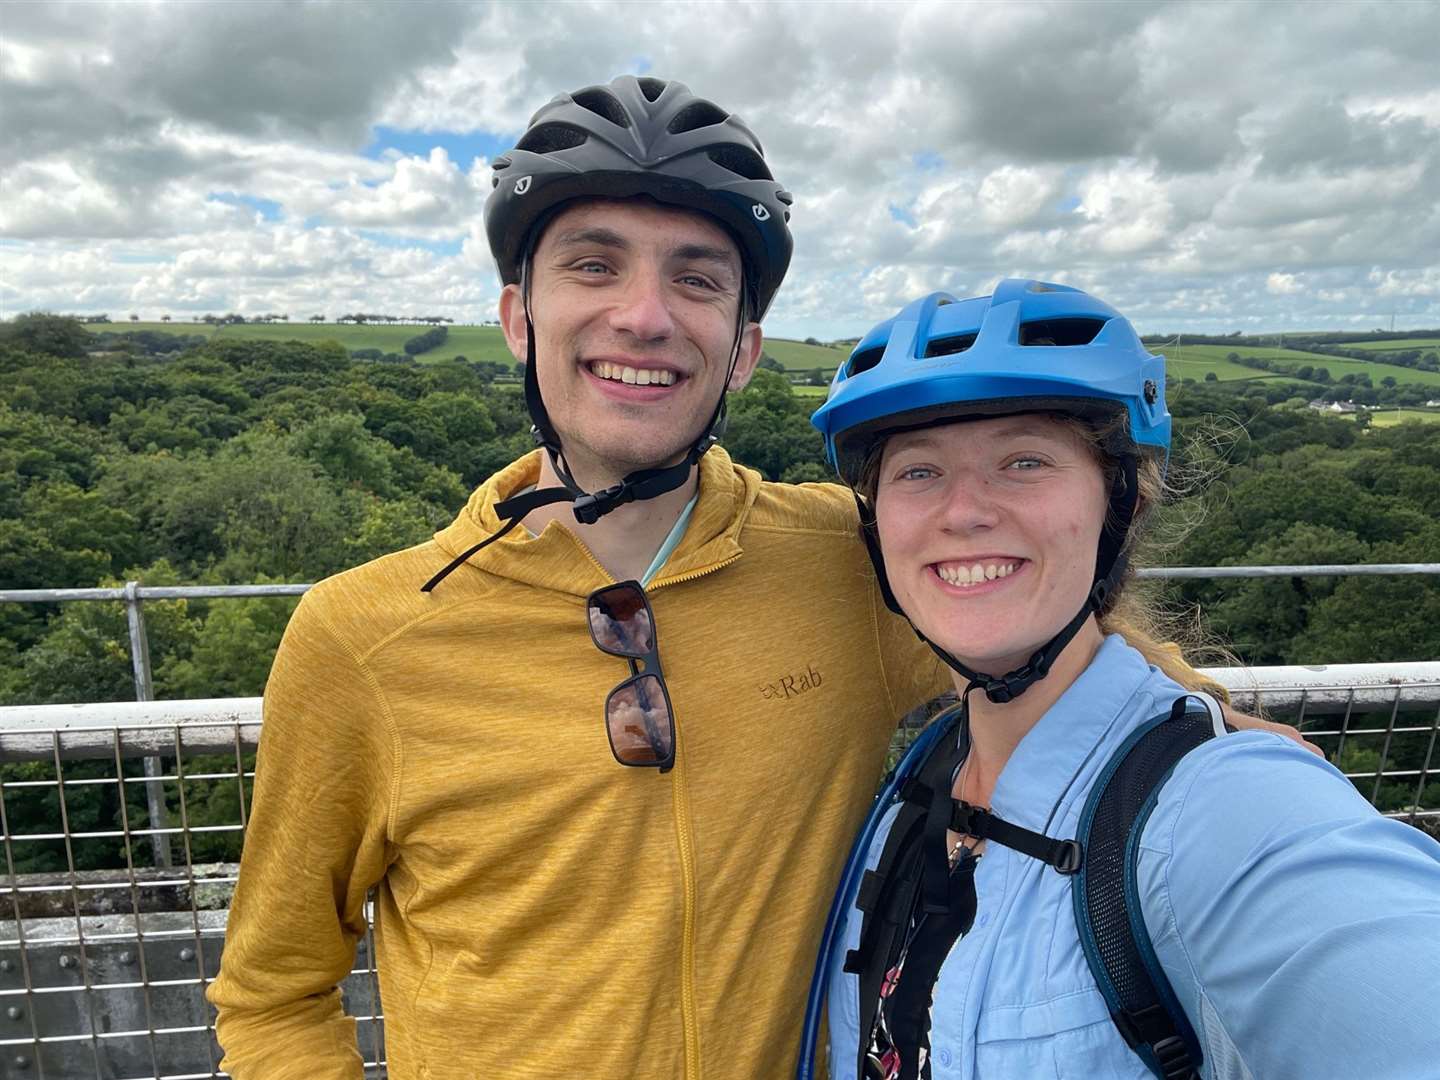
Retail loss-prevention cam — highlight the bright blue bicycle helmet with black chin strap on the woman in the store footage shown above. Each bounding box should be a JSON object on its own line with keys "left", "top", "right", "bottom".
{"left": 811, "top": 278, "right": 1171, "bottom": 701}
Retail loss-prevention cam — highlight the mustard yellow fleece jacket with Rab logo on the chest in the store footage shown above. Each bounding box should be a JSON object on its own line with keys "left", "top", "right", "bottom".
{"left": 209, "top": 448, "right": 949, "bottom": 1080}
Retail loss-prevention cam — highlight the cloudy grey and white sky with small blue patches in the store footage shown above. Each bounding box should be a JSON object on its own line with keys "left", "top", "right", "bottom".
{"left": 0, "top": 0, "right": 1440, "bottom": 340}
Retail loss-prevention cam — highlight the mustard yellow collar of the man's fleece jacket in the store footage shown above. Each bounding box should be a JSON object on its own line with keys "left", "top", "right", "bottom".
{"left": 435, "top": 446, "right": 760, "bottom": 596}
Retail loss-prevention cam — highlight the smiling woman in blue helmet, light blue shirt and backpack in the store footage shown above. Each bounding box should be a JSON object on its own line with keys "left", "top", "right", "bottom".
{"left": 802, "top": 281, "right": 1440, "bottom": 1080}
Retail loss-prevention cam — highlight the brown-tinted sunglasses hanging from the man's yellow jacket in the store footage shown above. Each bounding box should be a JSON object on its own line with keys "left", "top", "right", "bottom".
{"left": 586, "top": 582, "right": 675, "bottom": 772}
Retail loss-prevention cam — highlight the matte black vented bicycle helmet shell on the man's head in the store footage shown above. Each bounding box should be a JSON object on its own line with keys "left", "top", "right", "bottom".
{"left": 485, "top": 75, "right": 793, "bottom": 320}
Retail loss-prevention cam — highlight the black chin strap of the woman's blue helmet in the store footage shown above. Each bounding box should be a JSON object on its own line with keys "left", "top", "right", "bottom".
{"left": 855, "top": 454, "right": 1139, "bottom": 704}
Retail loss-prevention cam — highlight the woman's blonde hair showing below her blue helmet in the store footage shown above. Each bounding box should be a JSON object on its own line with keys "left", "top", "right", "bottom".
{"left": 855, "top": 410, "right": 1236, "bottom": 701}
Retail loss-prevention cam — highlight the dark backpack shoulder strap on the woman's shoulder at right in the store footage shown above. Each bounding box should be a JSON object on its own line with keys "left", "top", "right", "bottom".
{"left": 1073, "top": 693, "right": 1227, "bottom": 1080}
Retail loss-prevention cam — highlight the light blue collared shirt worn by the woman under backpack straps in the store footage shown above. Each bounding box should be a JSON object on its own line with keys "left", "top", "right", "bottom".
{"left": 827, "top": 636, "right": 1440, "bottom": 1080}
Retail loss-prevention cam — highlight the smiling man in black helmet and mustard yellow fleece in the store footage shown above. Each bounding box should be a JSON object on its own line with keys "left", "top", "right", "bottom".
{"left": 210, "top": 76, "right": 1307, "bottom": 1080}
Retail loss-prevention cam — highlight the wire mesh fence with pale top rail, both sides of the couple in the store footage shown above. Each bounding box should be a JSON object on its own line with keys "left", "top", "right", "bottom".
{"left": 0, "top": 664, "right": 1440, "bottom": 1080}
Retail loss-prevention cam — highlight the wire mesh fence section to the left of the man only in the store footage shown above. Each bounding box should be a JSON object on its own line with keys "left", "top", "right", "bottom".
{"left": 0, "top": 707, "right": 384, "bottom": 1080}
